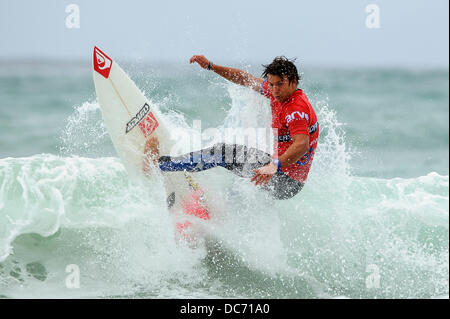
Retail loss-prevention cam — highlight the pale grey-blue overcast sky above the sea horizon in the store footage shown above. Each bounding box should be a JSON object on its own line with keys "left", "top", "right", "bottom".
{"left": 0, "top": 0, "right": 449, "bottom": 67}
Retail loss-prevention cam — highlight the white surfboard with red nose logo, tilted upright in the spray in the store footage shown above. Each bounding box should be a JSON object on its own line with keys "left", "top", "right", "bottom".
{"left": 93, "top": 47, "right": 210, "bottom": 237}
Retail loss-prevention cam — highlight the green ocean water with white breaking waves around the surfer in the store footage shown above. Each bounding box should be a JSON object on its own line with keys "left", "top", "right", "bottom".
{"left": 0, "top": 61, "right": 449, "bottom": 298}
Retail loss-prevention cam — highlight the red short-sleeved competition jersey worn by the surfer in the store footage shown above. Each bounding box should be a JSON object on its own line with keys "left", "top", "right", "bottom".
{"left": 260, "top": 81, "right": 319, "bottom": 183}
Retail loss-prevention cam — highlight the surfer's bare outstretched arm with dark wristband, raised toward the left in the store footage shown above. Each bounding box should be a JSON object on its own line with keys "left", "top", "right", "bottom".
{"left": 189, "top": 55, "right": 263, "bottom": 92}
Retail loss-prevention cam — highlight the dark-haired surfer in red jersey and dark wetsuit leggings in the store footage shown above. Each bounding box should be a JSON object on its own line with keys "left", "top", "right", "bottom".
{"left": 144, "top": 55, "right": 319, "bottom": 199}
